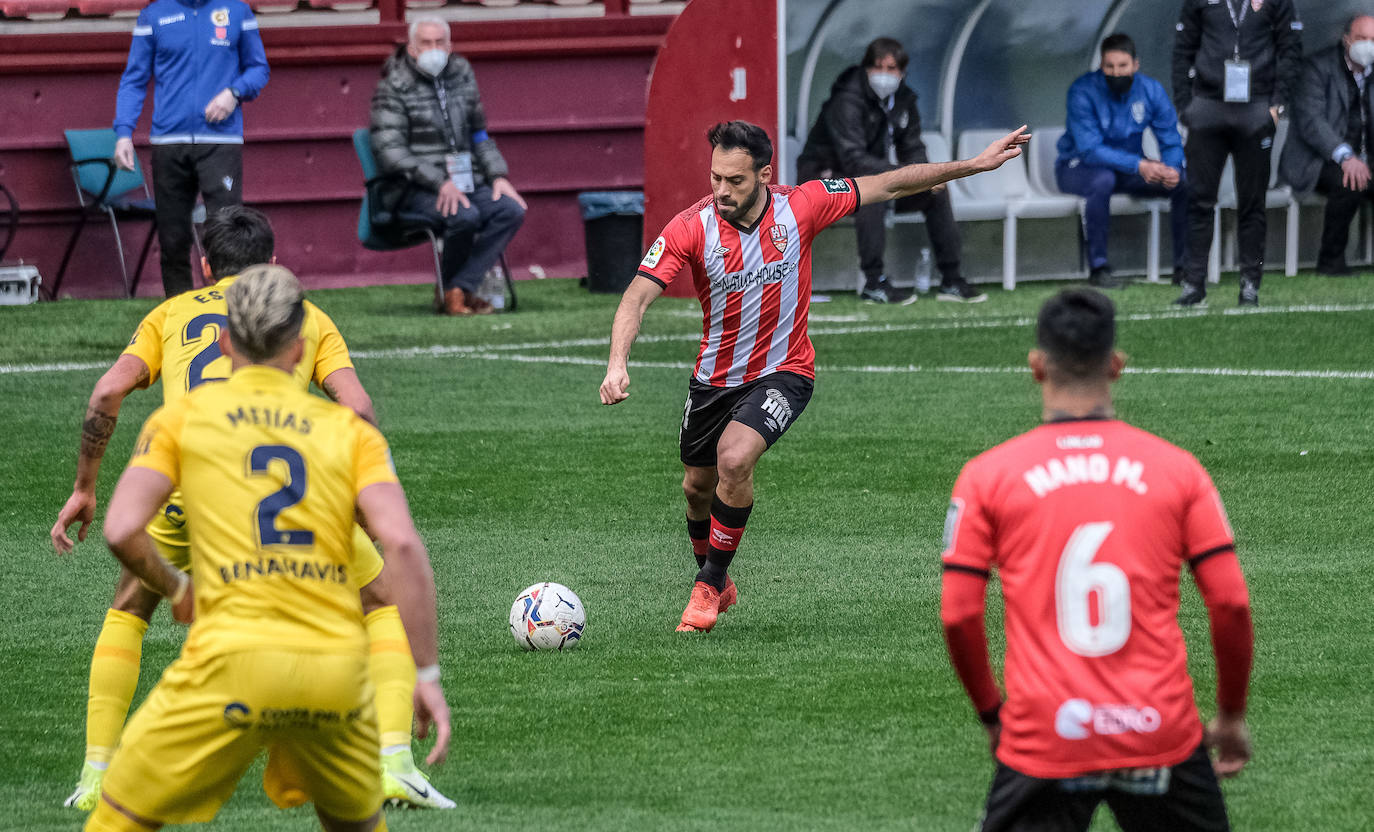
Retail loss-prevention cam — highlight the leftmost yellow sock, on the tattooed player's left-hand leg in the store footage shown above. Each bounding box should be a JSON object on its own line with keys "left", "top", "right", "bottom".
{"left": 87, "top": 610, "right": 148, "bottom": 765}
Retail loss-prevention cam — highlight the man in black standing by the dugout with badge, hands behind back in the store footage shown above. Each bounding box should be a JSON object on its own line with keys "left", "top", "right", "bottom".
{"left": 1173, "top": 0, "right": 1303, "bottom": 306}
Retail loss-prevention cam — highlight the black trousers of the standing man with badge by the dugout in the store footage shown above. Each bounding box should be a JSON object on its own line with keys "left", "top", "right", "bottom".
{"left": 1183, "top": 99, "right": 1275, "bottom": 288}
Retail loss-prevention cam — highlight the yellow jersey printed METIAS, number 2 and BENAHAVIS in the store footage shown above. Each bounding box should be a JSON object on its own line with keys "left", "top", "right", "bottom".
{"left": 129, "top": 365, "right": 397, "bottom": 659}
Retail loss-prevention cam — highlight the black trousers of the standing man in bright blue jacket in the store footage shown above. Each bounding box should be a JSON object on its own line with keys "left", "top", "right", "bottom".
{"left": 153, "top": 144, "right": 243, "bottom": 298}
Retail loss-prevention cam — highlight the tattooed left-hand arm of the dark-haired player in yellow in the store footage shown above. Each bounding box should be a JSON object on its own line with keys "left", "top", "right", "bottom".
{"left": 48, "top": 356, "right": 150, "bottom": 555}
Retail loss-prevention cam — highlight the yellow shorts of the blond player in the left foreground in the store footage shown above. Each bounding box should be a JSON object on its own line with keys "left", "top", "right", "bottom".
{"left": 102, "top": 651, "right": 382, "bottom": 824}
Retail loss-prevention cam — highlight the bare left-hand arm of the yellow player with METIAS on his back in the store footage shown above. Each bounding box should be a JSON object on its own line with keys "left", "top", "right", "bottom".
{"left": 104, "top": 468, "right": 195, "bottom": 623}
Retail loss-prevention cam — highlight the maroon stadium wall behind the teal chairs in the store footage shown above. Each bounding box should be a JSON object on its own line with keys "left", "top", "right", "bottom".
{"left": 0, "top": 16, "right": 672, "bottom": 297}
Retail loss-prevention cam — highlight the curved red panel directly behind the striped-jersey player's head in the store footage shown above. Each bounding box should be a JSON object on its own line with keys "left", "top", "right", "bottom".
{"left": 644, "top": 0, "right": 778, "bottom": 297}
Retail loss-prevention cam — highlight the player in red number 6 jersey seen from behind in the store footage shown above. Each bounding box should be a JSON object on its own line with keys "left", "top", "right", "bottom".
{"left": 941, "top": 290, "right": 1253, "bottom": 832}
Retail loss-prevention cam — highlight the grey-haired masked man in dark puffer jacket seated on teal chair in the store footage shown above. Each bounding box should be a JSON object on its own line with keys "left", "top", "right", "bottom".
{"left": 372, "top": 16, "right": 525, "bottom": 316}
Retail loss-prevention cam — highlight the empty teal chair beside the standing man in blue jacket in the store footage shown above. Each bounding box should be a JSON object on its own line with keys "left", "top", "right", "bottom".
{"left": 52, "top": 129, "right": 158, "bottom": 298}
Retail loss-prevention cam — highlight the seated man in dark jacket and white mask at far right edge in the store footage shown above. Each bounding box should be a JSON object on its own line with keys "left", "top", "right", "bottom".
{"left": 1279, "top": 15, "right": 1374, "bottom": 275}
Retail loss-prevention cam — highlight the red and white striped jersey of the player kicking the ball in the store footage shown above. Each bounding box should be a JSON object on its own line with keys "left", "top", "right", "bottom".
{"left": 639, "top": 178, "right": 859, "bottom": 387}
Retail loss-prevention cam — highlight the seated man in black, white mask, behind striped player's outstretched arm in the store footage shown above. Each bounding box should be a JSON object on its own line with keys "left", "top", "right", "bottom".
{"left": 797, "top": 37, "right": 988, "bottom": 303}
